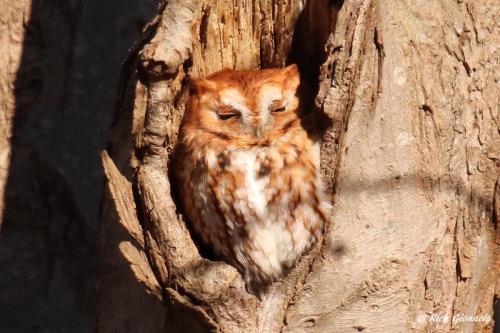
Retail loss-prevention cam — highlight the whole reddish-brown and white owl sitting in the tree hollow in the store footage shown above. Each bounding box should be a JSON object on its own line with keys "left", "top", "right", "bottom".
{"left": 174, "top": 65, "right": 328, "bottom": 289}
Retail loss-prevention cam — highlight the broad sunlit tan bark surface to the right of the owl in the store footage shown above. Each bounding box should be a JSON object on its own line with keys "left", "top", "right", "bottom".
{"left": 287, "top": 1, "right": 500, "bottom": 332}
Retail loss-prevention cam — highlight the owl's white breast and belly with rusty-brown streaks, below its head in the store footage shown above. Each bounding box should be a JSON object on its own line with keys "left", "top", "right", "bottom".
{"left": 181, "top": 131, "right": 328, "bottom": 285}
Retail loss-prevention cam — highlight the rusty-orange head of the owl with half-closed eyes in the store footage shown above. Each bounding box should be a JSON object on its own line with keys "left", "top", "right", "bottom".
{"left": 182, "top": 65, "right": 300, "bottom": 146}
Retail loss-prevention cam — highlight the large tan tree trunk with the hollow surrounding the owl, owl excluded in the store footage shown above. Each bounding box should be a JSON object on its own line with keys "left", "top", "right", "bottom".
{"left": 97, "top": 0, "right": 500, "bottom": 332}
